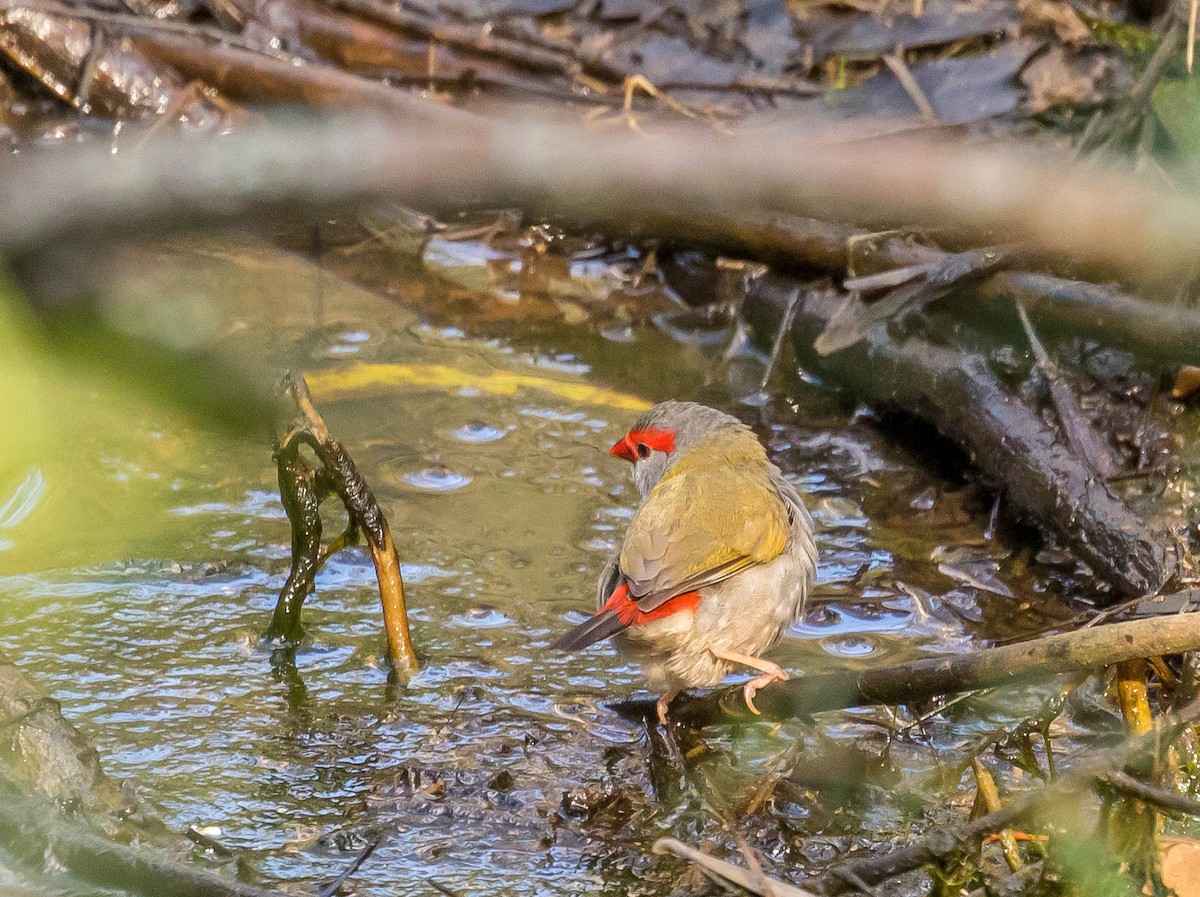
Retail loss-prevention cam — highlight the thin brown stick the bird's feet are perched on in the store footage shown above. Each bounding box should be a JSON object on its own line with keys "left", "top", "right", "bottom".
{"left": 616, "top": 590, "right": 1200, "bottom": 726}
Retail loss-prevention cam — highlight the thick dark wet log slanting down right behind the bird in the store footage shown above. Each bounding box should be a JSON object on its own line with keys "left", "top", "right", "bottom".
{"left": 746, "top": 277, "right": 1175, "bottom": 597}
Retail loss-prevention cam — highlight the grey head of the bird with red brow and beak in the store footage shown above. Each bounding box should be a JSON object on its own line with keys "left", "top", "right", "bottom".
{"left": 608, "top": 402, "right": 757, "bottom": 498}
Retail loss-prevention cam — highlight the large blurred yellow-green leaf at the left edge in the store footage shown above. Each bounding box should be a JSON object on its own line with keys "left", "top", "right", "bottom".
{"left": 0, "top": 259, "right": 275, "bottom": 572}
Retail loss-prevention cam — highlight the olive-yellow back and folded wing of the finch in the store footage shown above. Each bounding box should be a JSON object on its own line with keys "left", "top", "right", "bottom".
{"left": 620, "top": 468, "right": 788, "bottom": 610}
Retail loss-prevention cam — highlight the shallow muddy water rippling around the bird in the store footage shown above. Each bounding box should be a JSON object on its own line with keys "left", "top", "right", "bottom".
{"left": 0, "top": 238, "right": 1142, "bottom": 895}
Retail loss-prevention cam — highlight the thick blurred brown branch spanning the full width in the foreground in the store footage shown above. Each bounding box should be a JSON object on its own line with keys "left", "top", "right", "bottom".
{"left": 7, "top": 112, "right": 1200, "bottom": 287}
